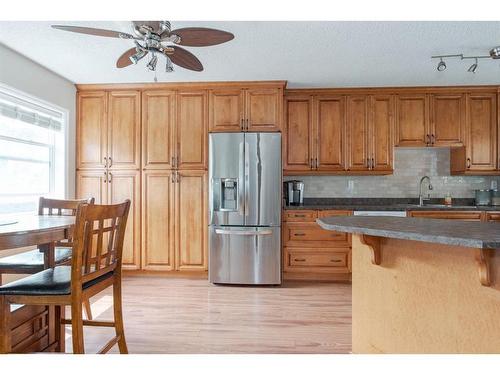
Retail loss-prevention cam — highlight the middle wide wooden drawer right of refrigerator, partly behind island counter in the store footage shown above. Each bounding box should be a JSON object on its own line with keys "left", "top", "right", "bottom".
{"left": 283, "top": 223, "right": 349, "bottom": 247}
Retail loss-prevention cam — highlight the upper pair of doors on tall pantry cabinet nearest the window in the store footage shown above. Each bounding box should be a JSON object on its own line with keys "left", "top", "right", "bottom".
{"left": 76, "top": 91, "right": 141, "bottom": 169}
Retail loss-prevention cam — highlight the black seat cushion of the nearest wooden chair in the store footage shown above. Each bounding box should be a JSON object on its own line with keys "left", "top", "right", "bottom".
{"left": 0, "top": 266, "right": 113, "bottom": 296}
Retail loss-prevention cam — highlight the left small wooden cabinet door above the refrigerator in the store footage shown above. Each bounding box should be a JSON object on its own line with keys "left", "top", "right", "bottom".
{"left": 209, "top": 89, "right": 245, "bottom": 132}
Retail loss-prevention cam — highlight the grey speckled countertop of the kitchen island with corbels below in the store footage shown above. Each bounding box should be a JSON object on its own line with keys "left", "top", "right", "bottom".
{"left": 317, "top": 216, "right": 500, "bottom": 249}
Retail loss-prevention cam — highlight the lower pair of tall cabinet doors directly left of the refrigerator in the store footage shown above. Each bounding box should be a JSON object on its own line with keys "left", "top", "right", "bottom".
{"left": 142, "top": 170, "right": 208, "bottom": 271}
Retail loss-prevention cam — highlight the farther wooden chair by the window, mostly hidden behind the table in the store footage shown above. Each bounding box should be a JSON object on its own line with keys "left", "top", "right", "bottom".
{"left": 0, "top": 197, "right": 94, "bottom": 320}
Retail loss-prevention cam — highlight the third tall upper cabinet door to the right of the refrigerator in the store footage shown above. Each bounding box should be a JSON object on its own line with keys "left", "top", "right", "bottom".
{"left": 347, "top": 96, "right": 369, "bottom": 171}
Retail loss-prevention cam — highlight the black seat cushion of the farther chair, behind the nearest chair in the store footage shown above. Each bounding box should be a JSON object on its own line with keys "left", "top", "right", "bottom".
{"left": 0, "top": 247, "right": 71, "bottom": 273}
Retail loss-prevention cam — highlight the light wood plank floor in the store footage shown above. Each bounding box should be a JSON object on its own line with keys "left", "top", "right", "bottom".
{"left": 66, "top": 276, "right": 351, "bottom": 354}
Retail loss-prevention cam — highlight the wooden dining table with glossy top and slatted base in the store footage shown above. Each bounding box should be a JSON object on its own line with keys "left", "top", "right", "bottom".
{"left": 0, "top": 215, "right": 75, "bottom": 353}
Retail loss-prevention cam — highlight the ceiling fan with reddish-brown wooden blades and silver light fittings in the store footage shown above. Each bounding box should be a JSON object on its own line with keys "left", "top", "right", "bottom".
{"left": 52, "top": 21, "right": 234, "bottom": 72}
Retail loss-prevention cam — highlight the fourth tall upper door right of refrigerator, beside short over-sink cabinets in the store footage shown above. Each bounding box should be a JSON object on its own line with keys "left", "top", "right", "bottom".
{"left": 369, "top": 95, "right": 394, "bottom": 171}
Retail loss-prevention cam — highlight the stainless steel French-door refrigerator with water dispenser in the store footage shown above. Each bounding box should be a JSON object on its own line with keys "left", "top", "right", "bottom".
{"left": 208, "top": 133, "right": 282, "bottom": 285}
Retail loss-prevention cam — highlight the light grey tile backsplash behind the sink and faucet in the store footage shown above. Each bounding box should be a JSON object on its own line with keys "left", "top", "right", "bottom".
{"left": 284, "top": 148, "right": 500, "bottom": 198}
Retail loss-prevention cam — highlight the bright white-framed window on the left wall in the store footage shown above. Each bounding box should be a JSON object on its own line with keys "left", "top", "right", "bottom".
{"left": 0, "top": 86, "right": 66, "bottom": 214}
